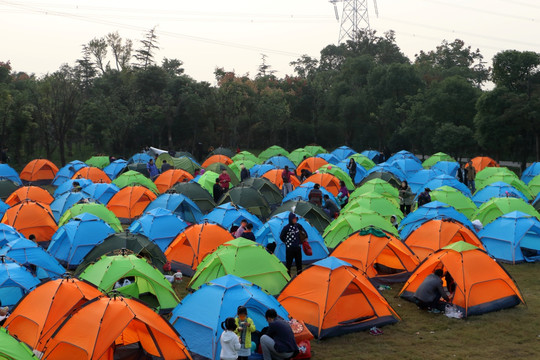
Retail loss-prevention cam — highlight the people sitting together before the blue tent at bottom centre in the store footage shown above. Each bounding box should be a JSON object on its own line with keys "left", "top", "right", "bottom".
{"left": 220, "top": 306, "right": 298, "bottom": 360}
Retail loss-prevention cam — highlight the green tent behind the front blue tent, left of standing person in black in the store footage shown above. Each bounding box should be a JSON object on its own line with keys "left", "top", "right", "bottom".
{"left": 189, "top": 238, "right": 291, "bottom": 295}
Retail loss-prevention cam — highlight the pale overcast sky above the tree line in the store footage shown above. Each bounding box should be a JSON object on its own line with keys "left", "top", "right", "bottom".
{"left": 0, "top": 0, "right": 540, "bottom": 83}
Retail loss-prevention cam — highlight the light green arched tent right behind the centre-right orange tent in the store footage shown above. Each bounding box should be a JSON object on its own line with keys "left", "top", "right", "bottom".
{"left": 323, "top": 213, "right": 398, "bottom": 249}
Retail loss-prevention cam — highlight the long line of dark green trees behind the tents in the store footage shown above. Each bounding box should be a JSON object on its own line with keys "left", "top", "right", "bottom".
{"left": 0, "top": 29, "right": 540, "bottom": 168}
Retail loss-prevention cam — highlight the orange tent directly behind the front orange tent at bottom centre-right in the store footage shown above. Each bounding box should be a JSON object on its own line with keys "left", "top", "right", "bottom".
{"left": 331, "top": 228, "right": 420, "bottom": 284}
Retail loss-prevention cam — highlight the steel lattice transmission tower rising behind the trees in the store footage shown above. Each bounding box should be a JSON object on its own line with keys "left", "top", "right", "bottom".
{"left": 330, "top": 0, "right": 379, "bottom": 43}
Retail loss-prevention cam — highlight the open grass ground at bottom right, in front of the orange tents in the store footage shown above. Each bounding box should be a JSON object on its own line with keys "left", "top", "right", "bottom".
{"left": 178, "top": 263, "right": 540, "bottom": 360}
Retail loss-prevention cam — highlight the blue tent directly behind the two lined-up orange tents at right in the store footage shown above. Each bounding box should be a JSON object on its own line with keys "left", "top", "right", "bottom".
{"left": 399, "top": 201, "right": 474, "bottom": 241}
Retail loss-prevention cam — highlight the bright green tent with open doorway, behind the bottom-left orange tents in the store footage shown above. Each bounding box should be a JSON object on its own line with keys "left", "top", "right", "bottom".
{"left": 79, "top": 255, "right": 180, "bottom": 312}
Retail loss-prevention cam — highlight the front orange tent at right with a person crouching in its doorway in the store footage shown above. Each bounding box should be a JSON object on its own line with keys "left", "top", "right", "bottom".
{"left": 400, "top": 242, "right": 525, "bottom": 317}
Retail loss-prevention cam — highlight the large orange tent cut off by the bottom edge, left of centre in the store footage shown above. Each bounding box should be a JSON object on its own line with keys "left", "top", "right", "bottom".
{"left": 43, "top": 296, "right": 191, "bottom": 360}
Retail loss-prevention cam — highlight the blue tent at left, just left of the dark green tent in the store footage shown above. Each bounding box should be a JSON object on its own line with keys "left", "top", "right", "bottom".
{"left": 47, "top": 213, "right": 115, "bottom": 269}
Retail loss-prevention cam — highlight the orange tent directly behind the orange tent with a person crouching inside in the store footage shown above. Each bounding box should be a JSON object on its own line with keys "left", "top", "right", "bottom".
{"left": 405, "top": 220, "right": 484, "bottom": 261}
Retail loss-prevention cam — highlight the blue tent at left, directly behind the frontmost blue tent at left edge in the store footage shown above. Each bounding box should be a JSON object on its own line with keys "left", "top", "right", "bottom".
{"left": 0, "top": 238, "right": 66, "bottom": 280}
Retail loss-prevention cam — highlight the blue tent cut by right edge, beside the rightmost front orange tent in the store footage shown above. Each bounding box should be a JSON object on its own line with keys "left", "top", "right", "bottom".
{"left": 478, "top": 211, "right": 540, "bottom": 264}
